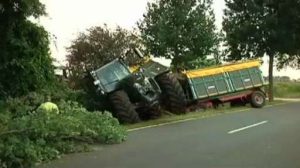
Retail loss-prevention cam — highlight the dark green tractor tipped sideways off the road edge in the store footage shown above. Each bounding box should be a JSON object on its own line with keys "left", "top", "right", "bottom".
{"left": 91, "top": 49, "right": 186, "bottom": 123}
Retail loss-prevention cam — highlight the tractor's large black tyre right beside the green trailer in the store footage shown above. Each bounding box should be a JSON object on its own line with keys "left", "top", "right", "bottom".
{"left": 156, "top": 73, "right": 186, "bottom": 114}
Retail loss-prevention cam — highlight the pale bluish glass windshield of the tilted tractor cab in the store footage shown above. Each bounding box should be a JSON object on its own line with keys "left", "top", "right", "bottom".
{"left": 96, "top": 60, "right": 130, "bottom": 86}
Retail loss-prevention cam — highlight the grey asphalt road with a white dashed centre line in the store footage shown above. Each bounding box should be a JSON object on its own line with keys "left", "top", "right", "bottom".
{"left": 42, "top": 102, "right": 300, "bottom": 168}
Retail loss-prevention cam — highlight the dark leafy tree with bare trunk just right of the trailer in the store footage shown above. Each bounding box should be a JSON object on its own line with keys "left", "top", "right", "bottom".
{"left": 223, "top": 0, "right": 300, "bottom": 101}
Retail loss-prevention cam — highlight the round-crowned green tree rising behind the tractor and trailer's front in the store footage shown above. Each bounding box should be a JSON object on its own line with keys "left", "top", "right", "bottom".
{"left": 138, "top": 0, "right": 219, "bottom": 68}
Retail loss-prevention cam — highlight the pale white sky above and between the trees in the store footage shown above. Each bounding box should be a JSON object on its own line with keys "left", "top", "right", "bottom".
{"left": 40, "top": 0, "right": 300, "bottom": 78}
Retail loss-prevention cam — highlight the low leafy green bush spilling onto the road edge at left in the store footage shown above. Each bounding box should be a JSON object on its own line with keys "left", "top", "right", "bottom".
{"left": 0, "top": 100, "right": 126, "bottom": 168}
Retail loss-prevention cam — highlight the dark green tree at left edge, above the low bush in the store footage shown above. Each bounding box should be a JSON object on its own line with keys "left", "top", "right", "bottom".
{"left": 0, "top": 0, "right": 54, "bottom": 98}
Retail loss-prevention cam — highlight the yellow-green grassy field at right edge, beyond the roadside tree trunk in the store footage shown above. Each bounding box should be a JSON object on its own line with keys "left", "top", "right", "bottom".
{"left": 274, "top": 82, "right": 300, "bottom": 98}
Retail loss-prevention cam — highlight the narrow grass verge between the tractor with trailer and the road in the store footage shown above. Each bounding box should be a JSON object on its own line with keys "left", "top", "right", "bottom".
{"left": 125, "top": 100, "right": 286, "bottom": 131}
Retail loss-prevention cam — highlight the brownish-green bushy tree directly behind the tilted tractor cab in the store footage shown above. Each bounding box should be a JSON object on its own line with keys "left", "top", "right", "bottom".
{"left": 67, "top": 25, "right": 140, "bottom": 89}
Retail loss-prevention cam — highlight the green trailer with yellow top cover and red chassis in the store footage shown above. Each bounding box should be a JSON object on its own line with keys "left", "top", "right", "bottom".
{"left": 181, "top": 60, "right": 267, "bottom": 108}
